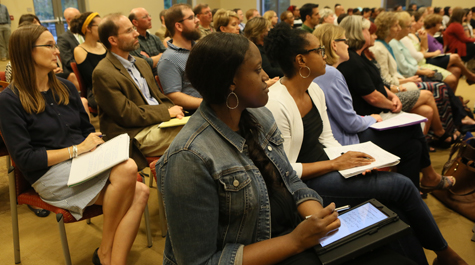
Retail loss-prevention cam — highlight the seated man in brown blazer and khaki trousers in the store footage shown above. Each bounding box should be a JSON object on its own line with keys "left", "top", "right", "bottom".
{"left": 92, "top": 14, "right": 184, "bottom": 169}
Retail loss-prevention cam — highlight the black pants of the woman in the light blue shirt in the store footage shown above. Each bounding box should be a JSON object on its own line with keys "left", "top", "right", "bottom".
{"left": 358, "top": 124, "right": 431, "bottom": 187}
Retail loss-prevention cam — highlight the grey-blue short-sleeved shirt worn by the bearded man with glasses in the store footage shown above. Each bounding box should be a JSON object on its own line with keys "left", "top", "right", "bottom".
{"left": 157, "top": 39, "right": 201, "bottom": 98}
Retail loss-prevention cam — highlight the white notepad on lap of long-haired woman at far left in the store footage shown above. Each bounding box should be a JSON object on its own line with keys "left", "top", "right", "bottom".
{"left": 68, "top": 133, "right": 130, "bottom": 187}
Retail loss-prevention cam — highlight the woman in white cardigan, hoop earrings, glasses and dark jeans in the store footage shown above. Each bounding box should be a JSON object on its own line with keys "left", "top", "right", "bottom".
{"left": 265, "top": 22, "right": 466, "bottom": 264}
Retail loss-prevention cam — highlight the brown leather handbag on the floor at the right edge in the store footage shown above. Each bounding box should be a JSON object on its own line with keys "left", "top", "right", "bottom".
{"left": 432, "top": 137, "right": 475, "bottom": 221}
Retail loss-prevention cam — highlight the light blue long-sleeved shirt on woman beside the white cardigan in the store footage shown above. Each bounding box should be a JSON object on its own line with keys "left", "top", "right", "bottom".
{"left": 313, "top": 65, "right": 376, "bottom": 145}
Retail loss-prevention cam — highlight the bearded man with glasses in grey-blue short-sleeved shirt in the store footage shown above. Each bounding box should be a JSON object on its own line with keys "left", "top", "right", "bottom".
{"left": 157, "top": 4, "right": 203, "bottom": 113}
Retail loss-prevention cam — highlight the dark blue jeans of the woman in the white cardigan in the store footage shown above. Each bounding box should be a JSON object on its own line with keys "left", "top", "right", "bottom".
{"left": 305, "top": 171, "right": 447, "bottom": 264}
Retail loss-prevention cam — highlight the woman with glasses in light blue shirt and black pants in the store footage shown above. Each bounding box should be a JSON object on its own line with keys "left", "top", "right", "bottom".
{"left": 314, "top": 22, "right": 453, "bottom": 192}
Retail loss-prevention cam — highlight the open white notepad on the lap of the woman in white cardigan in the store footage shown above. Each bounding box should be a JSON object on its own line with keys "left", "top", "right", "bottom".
{"left": 324, "top": 141, "right": 400, "bottom": 178}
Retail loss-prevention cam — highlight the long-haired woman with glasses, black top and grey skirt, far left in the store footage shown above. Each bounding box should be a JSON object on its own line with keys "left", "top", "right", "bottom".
{"left": 0, "top": 25, "right": 149, "bottom": 265}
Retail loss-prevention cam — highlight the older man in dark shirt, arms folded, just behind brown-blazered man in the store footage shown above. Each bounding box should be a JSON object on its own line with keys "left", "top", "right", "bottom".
{"left": 129, "top": 7, "right": 167, "bottom": 75}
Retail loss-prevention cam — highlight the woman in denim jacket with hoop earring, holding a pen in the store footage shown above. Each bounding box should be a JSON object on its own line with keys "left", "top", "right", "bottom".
{"left": 156, "top": 33, "right": 340, "bottom": 264}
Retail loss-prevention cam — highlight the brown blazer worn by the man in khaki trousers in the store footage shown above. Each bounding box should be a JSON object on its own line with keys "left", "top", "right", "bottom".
{"left": 92, "top": 52, "right": 174, "bottom": 169}
